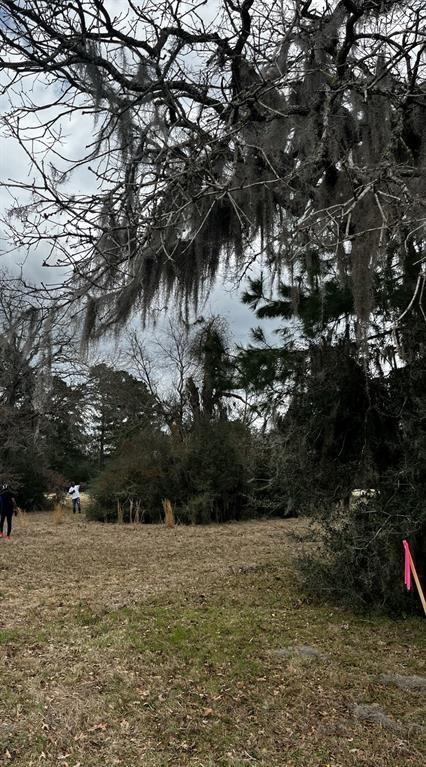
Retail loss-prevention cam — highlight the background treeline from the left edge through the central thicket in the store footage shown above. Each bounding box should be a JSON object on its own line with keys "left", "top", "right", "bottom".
{"left": 0, "top": 304, "right": 266, "bottom": 523}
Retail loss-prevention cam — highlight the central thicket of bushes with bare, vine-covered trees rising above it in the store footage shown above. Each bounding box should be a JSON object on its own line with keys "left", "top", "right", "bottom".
{"left": 90, "top": 318, "right": 256, "bottom": 523}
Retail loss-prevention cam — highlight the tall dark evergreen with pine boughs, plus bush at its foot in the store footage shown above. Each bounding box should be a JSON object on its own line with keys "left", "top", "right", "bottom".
{"left": 240, "top": 259, "right": 426, "bottom": 610}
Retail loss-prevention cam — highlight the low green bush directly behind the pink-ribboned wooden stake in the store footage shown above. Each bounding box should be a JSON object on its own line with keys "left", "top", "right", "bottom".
{"left": 299, "top": 488, "right": 426, "bottom": 614}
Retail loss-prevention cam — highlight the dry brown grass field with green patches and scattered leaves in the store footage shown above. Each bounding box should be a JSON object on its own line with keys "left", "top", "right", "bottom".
{"left": 0, "top": 511, "right": 426, "bottom": 767}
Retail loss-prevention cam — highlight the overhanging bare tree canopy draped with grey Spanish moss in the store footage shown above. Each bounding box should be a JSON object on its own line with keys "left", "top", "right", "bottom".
{"left": 0, "top": 0, "right": 426, "bottom": 336}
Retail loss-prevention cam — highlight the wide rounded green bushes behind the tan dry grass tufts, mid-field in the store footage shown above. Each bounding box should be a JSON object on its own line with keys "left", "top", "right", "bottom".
{"left": 86, "top": 420, "right": 250, "bottom": 524}
